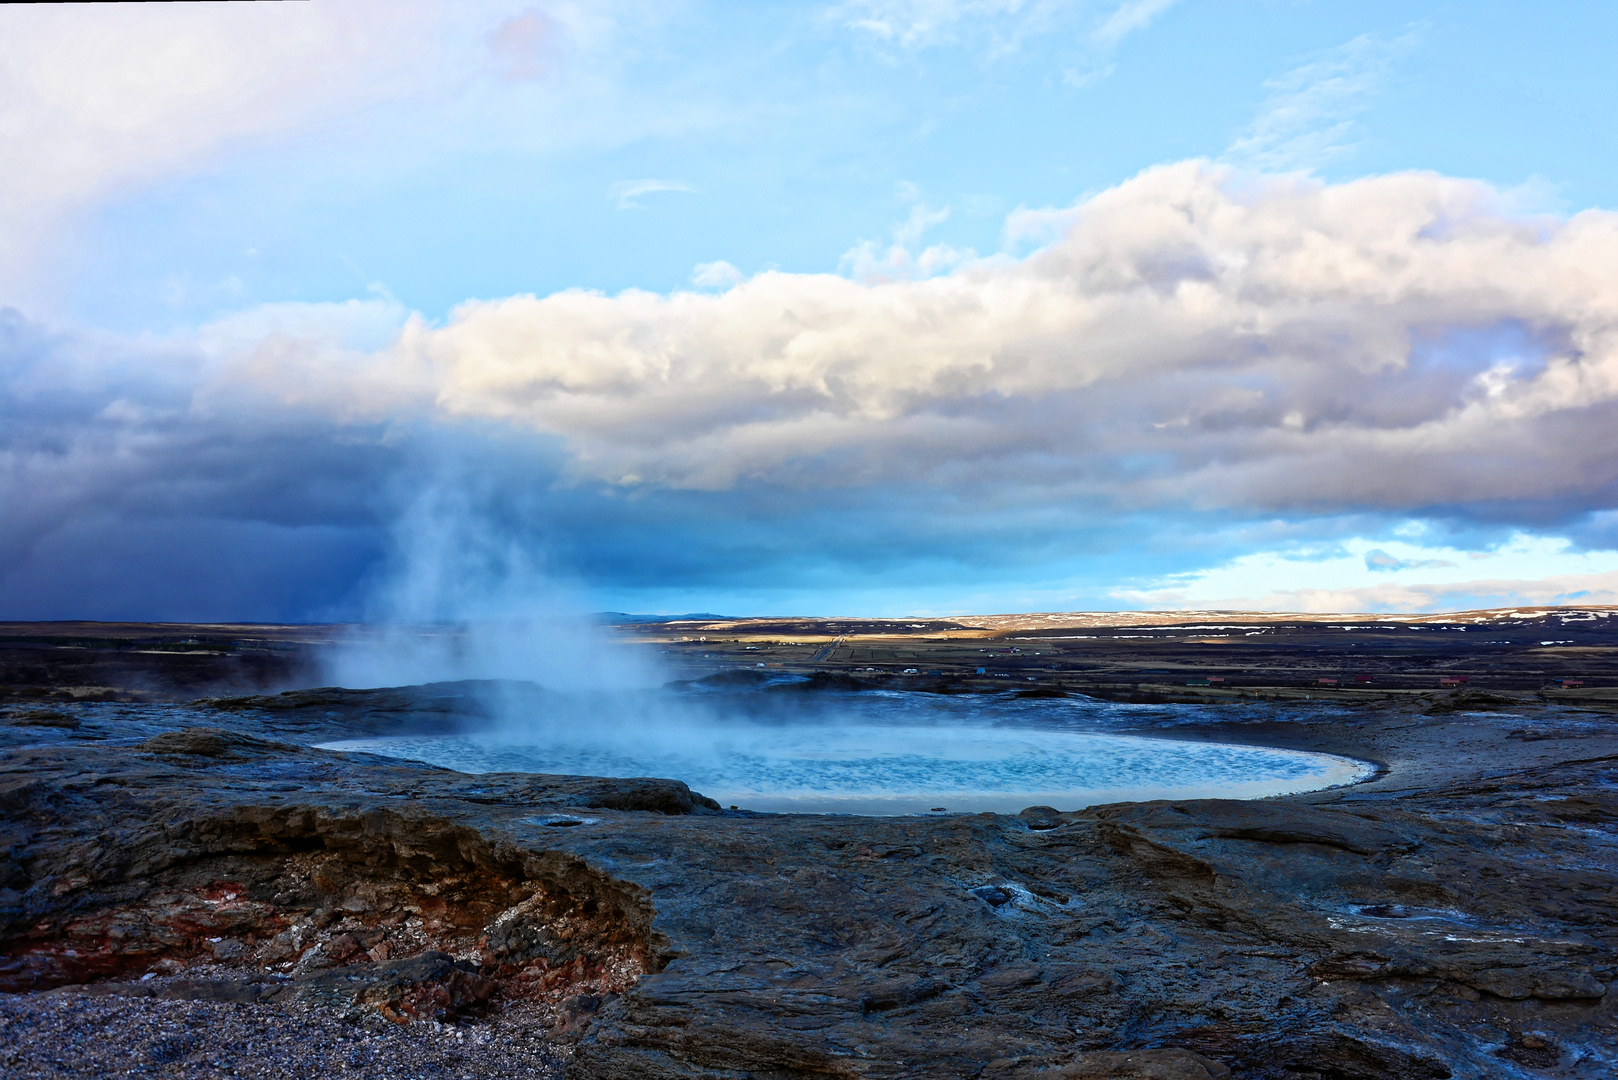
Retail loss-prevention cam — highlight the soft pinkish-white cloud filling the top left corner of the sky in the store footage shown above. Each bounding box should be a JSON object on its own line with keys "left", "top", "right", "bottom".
{"left": 0, "top": 0, "right": 625, "bottom": 313}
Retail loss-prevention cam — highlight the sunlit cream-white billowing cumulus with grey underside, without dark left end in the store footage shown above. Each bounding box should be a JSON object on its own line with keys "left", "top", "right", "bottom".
{"left": 328, "top": 162, "right": 1618, "bottom": 527}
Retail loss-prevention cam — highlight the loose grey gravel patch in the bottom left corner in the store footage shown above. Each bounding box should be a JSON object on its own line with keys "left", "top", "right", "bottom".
{"left": 0, "top": 988, "right": 566, "bottom": 1080}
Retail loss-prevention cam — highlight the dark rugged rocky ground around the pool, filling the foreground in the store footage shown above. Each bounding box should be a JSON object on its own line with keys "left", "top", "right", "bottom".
{"left": 0, "top": 691, "right": 1618, "bottom": 1080}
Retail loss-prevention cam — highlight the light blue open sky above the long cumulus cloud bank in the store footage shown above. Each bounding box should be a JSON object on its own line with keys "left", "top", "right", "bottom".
{"left": 42, "top": 0, "right": 1618, "bottom": 330}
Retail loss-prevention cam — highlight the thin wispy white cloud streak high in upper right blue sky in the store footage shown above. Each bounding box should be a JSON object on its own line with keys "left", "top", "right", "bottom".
{"left": 1223, "top": 31, "right": 1419, "bottom": 172}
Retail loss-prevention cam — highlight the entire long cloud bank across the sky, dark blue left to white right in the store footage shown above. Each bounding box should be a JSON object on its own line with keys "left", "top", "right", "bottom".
{"left": 9, "top": 162, "right": 1618, "bottom": 615}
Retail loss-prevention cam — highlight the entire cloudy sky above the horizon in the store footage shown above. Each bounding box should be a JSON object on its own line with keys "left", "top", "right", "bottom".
{"left": 0, "top": 0, "right": 1618, "bottom": 622}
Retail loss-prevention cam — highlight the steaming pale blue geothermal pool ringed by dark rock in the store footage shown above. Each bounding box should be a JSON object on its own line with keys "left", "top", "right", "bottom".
{"left": 324, "top": 693, "right": 1372, "bottom": 814}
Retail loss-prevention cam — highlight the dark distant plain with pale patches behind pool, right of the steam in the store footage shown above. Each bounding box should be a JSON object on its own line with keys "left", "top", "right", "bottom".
{"left": 621, "top": 607, "right": 1618, "bottom": 704}
